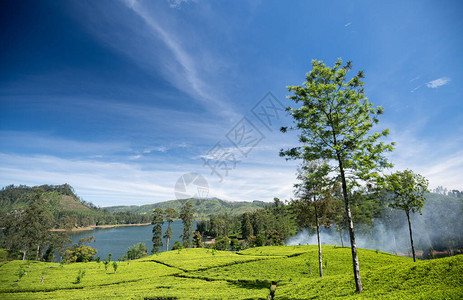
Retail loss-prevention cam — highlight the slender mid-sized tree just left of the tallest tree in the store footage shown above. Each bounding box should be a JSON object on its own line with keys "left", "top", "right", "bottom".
{"left": 291, "top": 161, "right": 333, "bottom": 277}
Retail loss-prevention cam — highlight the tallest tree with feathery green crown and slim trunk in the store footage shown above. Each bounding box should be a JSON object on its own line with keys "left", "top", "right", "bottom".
{"left": 280, "top": 59, "right": 393, "bottom": 292}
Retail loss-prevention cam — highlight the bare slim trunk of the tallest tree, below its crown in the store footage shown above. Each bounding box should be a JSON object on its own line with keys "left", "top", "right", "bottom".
{"left": 337, "top": 153, "right": 363, "bottom": 293}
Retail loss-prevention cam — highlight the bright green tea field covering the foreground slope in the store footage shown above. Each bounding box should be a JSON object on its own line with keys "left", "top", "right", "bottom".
{"left": 0, "top": 246, "right": 463, "bottom": 299}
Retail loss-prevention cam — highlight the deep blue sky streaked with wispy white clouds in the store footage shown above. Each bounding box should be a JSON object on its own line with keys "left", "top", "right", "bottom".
{"left": 0, "top": 0, "right": 463, "bottom": 206}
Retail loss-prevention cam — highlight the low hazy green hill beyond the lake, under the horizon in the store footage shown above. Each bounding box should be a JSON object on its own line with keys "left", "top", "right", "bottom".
{"left": 105, "top": 198, "right": 269, "bottom": 219}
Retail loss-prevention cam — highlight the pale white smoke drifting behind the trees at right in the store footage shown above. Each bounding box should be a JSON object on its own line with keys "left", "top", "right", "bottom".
{"left": 286, "top": 198, "right": 463, "bottom": 255}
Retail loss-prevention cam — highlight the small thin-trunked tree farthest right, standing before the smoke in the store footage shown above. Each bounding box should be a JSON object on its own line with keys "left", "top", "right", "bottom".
{"left": 386, "top": 170, "right": 428, "bottom": 262}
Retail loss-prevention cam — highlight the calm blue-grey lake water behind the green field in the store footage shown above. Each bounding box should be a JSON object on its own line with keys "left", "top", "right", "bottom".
{"left": 63, "top": 220, "right": 196, "bottom": 260}
